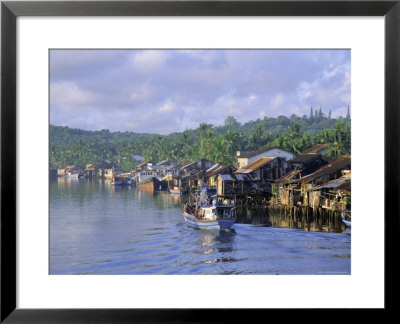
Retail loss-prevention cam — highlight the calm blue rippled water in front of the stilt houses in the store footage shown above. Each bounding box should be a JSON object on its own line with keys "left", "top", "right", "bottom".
{"left": 50, "top": 178, "right": 351, "bottom": 275}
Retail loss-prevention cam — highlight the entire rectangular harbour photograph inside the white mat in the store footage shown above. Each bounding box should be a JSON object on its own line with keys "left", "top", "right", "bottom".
{"left": 48, "top": 49, "right": 350, "bottom": 275}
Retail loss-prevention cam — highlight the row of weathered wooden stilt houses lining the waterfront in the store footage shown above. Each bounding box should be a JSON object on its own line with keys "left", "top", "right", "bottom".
{"left": 50, "top": 111, "right": 351, "bottom": 231}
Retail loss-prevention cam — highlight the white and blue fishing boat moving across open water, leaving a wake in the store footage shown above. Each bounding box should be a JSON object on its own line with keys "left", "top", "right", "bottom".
{"left": 183, "top": 196, "right": 236, "bottom": 230}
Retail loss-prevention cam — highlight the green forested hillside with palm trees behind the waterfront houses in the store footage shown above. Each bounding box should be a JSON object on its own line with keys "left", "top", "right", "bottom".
{"left": 49, "top": 109, "right": 351, "bottom": 171}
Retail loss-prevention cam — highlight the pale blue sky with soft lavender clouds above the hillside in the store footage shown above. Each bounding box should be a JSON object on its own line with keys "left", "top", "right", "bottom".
{"left": 50, "top": 49, "right": 351, "bottom": 135}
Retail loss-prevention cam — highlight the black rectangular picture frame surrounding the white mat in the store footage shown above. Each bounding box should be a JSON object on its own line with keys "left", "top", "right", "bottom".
{"left": 0, "top": 0, "right": 400, "bottom": 323}
